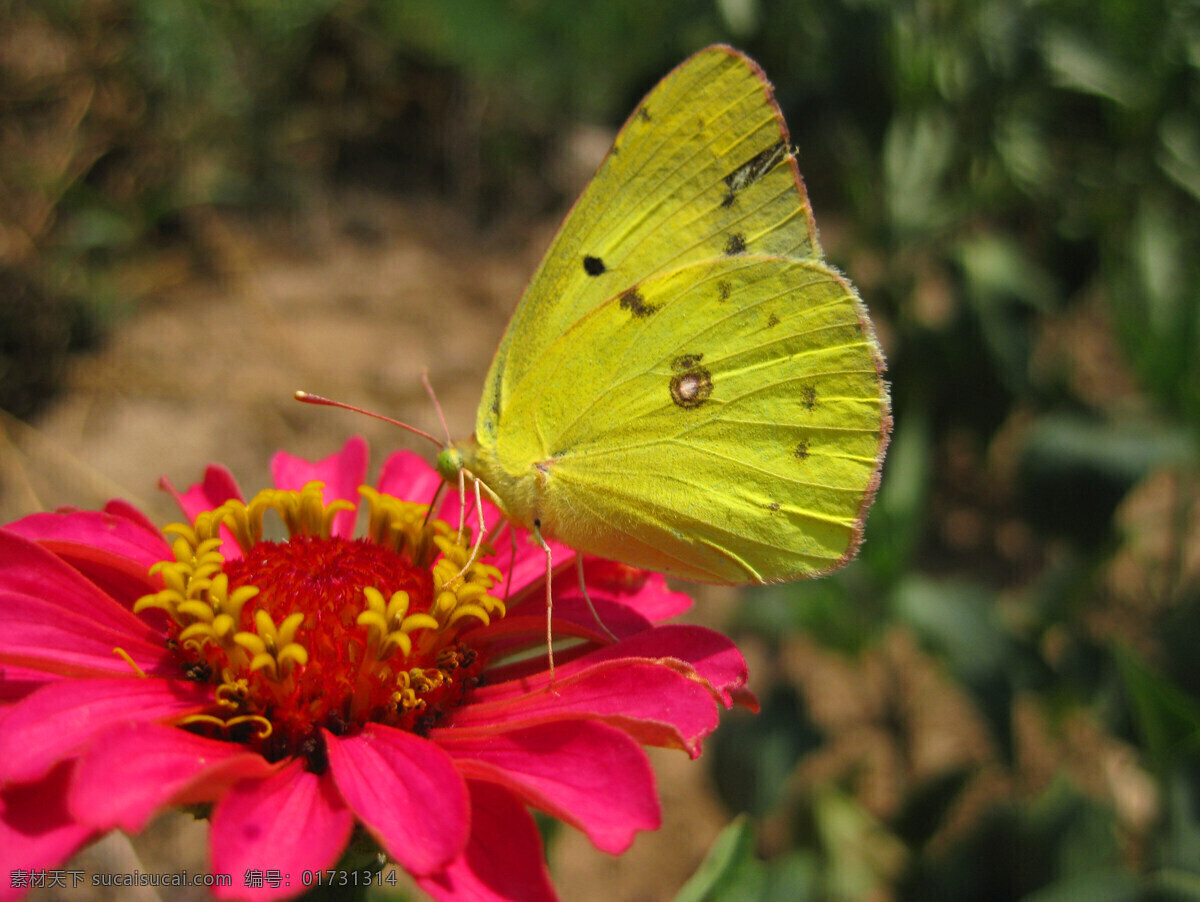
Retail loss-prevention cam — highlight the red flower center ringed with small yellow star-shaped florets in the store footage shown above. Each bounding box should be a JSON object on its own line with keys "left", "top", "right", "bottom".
{"left": 134, "top": 483, "right": 504, "bottom": 770}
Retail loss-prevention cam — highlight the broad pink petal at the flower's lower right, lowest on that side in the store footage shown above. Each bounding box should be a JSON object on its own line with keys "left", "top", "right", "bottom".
{"left": 430, "top": 720, "right": 661, "bottom": 854}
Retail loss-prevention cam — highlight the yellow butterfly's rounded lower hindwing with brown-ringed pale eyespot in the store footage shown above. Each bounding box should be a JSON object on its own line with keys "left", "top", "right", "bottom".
{"left": 497, "top": 255, "right": 887, "bottom": 583}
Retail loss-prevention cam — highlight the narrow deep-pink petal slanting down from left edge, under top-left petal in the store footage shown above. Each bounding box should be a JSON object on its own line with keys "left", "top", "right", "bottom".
{"left": 0, "top": 528, "right": 158, "bottom": 641}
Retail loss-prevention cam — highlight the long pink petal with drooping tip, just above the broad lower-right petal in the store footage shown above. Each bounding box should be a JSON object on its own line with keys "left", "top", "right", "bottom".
{"left": 448, "top": 659, "right": 718, "bottom": 758}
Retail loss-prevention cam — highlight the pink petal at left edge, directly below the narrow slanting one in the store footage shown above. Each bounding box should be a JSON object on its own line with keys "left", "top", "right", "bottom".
{"left": 0, "top": 591, "right": 179, "bottom": 677}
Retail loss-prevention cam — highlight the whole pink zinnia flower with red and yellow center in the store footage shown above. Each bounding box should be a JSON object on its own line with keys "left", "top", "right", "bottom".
{"left": 0, "top": 439, "right": 754, "bottom": 902}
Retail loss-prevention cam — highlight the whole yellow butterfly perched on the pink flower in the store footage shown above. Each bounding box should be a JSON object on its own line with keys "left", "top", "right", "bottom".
{"left": 438, "top": 47, "right": 892, "bottom": 584}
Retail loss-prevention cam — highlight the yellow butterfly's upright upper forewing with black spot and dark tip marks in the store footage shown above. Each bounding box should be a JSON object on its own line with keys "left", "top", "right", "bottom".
{"left": 476, "top": 47, "right": 820, "bottom": 440}
